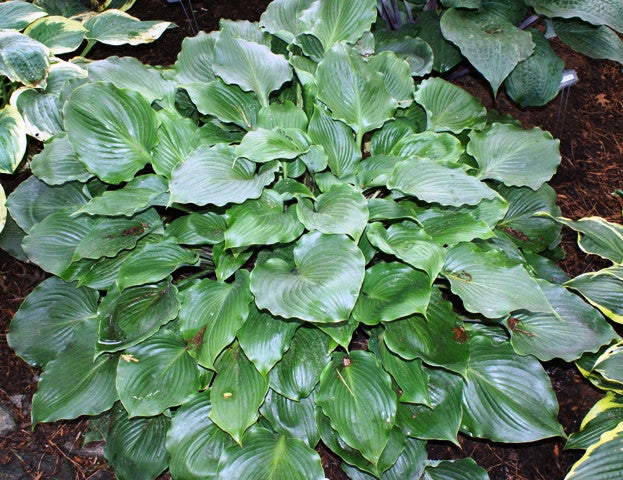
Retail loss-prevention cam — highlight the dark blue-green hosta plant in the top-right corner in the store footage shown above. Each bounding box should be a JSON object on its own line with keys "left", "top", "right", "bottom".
{"left": 378, "top": 0, "right": 623, "bottom": 106}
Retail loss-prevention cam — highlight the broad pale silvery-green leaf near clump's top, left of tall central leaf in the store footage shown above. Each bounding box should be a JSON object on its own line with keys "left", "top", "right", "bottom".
{"left": 213, "top": 34, "right": 292, "bottom": 107}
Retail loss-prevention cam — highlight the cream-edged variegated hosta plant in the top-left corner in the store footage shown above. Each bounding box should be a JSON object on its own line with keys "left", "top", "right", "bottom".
{"left": 0, "top": 0, "right": 173, "bottom": 173}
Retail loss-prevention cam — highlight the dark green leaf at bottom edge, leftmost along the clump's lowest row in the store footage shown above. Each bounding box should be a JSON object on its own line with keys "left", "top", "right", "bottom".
{"left": 104, "top": 407, "right": 170, "bottom": 480}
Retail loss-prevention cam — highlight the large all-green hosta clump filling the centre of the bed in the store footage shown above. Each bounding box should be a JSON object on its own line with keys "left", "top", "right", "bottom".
{"left": 3, "top": 0, "right": 615, "bottom": 480}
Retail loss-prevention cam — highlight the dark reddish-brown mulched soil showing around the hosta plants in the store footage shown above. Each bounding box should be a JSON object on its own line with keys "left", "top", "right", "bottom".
{"left": 0, "top": 0, "right": 623, "bottom": 480}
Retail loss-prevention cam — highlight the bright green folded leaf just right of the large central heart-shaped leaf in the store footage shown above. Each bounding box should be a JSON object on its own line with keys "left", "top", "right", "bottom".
{"left": 366, "top": 221, "right": 445, "bottom": 284}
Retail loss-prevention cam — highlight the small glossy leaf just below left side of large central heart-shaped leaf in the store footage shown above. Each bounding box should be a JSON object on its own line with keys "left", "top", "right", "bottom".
{"left": 236, "top": 304, "right": 300, "bottom": 376}
